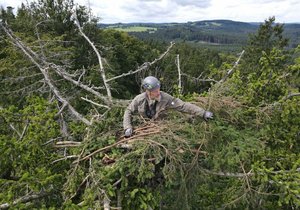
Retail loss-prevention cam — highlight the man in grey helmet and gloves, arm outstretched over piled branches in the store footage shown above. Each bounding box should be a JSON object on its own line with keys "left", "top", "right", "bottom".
{"left": 123, "top": 76, "right": 213, "bottom": 137}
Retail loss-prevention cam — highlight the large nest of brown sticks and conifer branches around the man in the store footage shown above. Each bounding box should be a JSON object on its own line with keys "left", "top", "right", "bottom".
{"left": 65, "top": 97, "right": 253, "bottom": 208}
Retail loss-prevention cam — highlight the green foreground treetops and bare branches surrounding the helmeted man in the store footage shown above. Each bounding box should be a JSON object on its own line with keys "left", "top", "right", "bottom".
{"left": 0, "top": 0, "right": 300, "bottom": 210}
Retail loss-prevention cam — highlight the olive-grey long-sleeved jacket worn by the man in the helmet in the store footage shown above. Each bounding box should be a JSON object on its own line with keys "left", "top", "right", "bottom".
{"left": 123, "top": 91, "right": 205, "bottom": 130}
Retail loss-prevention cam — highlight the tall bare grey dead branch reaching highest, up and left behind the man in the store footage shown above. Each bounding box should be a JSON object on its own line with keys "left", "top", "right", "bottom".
{"left": 73, "top": 11, "right": 112, "bottom": 102}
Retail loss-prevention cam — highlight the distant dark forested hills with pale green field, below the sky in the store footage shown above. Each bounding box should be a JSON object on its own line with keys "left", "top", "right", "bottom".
{"left": 99, "top": 20, "right": 300, "bottom": 51}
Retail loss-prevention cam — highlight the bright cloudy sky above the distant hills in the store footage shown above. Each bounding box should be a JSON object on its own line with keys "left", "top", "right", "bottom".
{"left": 0, "top": 0, "right": 300, "bottom": 23}
